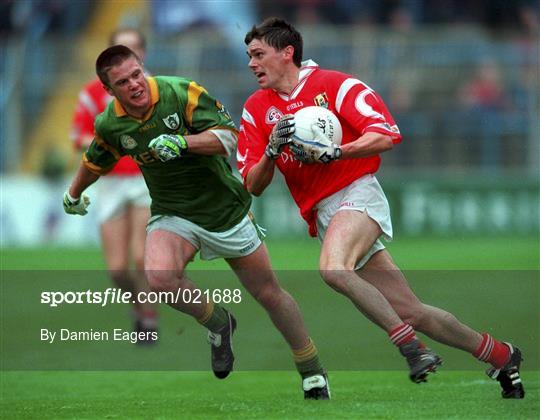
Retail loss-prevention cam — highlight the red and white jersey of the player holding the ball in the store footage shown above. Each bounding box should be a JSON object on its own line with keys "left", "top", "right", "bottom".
{"left": 237, "top": 60, "right": 401, "bottom": 236}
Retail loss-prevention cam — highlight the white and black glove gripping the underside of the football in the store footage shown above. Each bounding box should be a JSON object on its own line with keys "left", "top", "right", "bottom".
{"left": 289, "top": 124, "right": 341, "bottom": 163}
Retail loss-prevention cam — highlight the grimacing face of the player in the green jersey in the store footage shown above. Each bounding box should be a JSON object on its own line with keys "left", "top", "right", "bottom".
{"left": 107, "top": 57, "right": 151, "bottom": 118}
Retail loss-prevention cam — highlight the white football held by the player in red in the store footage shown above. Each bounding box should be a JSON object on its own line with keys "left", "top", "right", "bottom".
{"left": 293, "top": 106, "right": 343, "bottom": 145}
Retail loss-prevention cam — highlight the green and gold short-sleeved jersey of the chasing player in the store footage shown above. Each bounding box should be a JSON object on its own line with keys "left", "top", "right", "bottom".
{"left": 83, "top": 76, "right": 251, "bottom": 232}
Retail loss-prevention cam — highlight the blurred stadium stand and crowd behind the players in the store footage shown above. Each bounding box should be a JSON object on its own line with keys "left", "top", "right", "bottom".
{"left": 0, "top": 0, "right": 540, "bottom": 244}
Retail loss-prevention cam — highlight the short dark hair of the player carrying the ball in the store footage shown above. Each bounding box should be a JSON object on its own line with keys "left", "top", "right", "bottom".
{"left": 244, "top": 17, "right": 304, "bottom": 67}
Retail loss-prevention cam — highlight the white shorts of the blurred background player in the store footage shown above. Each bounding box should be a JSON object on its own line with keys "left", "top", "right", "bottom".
{"left": 95, "top": 175, "right": 152, "bottom": 224}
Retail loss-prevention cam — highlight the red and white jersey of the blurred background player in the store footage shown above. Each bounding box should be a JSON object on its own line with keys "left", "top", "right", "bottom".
{"left": 70, "top": 79, "right": 141, "bottom": 176}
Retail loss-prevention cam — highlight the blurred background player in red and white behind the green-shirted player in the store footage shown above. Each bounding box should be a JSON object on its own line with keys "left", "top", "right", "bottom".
{"left": 71, "top": 28, "right": 157, "bottom": 344}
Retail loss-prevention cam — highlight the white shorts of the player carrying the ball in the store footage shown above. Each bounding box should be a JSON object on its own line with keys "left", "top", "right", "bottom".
{"left": 316, "top": 174, "right": 392, "bottom": 270}
